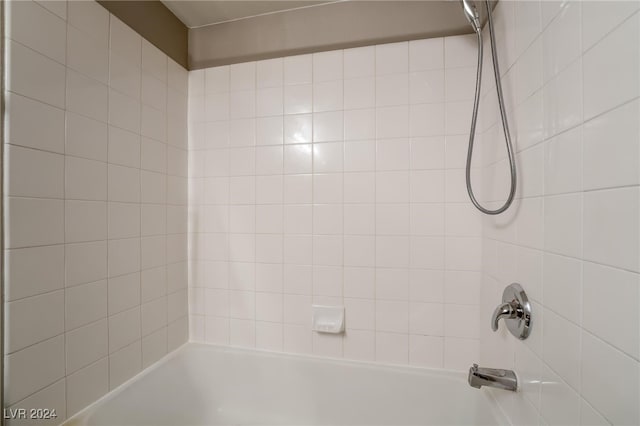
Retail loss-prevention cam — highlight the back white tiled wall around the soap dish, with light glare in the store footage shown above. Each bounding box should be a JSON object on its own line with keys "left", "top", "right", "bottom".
{"left": 189, "top": 36, "right": 488, "bottom": 369}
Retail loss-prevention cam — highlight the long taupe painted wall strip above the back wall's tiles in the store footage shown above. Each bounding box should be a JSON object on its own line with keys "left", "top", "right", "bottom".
{"left": 189, "top": 1, "right": 480, "bottom": 69}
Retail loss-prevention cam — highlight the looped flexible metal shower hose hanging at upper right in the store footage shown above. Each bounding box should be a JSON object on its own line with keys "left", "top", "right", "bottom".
{"left": 466, "top": 0, "right": 516, "bottom": 215}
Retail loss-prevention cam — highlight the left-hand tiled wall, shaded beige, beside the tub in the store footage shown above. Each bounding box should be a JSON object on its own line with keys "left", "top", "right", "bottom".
{"left": 4, "top": 1, "right": 188, "bottom": 424}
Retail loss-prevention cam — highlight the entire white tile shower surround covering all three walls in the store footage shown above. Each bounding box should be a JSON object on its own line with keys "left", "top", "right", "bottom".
{"left": 4, "top": 0, "right": 640, "bottom": 425}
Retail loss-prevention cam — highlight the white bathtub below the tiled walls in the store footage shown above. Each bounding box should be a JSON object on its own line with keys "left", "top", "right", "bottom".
{"left": 65, "top": 343, "right": 507, "bottom": 426}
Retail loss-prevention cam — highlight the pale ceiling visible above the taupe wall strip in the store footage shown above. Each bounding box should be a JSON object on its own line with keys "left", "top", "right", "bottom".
{"left": 162, "top": 0, "right": 335, "bottom": 28}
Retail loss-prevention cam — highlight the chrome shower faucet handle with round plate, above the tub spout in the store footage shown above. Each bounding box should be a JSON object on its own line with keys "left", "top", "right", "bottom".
{"left": 491, "top": 283, "right": 531, "bottom": 340}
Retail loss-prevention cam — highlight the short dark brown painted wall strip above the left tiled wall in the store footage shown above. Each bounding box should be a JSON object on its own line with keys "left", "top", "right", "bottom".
{"left": 98, "top": 0, "right": 189, "bottom": 68}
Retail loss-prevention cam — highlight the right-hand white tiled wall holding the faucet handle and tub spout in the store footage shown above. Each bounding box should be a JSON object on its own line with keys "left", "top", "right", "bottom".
{"left": 480, "top": 1, "right": 640, "bottom": 425}
